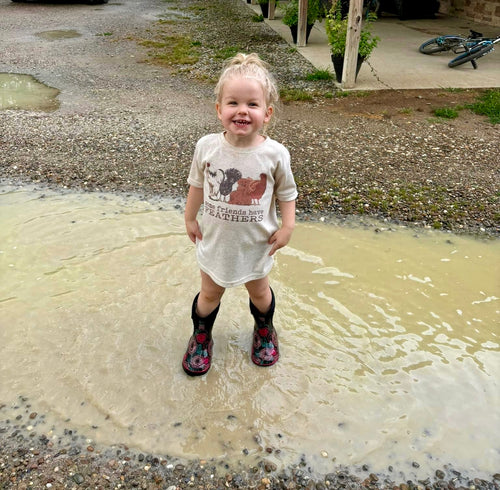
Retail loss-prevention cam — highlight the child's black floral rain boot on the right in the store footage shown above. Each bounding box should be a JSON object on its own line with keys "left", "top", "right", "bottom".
{"left": 250, "top": 289, "right": 280, "bottom": 367}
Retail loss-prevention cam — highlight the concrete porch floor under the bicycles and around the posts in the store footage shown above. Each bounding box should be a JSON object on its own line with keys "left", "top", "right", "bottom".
{"left": 250, "top": 5, "right": 500, "bottom": 90}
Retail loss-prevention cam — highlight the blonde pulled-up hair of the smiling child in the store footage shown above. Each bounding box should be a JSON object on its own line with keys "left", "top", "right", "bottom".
{"left": 214, "top": 53, "right": 279, "bottom": 108}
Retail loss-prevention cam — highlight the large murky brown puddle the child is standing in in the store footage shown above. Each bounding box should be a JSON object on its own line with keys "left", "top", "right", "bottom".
{"left": 0, "top": 187, "right": 500, "bottom": 477}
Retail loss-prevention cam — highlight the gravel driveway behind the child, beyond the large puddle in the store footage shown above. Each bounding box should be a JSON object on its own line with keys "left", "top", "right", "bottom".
{"left": 0, "top": 0, "right": 500, "bottom": 236}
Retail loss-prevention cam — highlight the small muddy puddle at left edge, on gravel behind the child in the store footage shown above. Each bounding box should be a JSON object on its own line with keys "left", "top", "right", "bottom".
{"left": 0, "top": 73, "right": 60, "bottom": 112}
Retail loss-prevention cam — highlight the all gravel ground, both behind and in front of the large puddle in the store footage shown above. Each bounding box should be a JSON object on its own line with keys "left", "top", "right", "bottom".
{"left": 0, "top": 0, "right": 500, "bottom": 490}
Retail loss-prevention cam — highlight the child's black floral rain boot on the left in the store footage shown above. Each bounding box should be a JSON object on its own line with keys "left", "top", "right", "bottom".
{"left": 182, "top": 293, "right": 220, "bottom": 376}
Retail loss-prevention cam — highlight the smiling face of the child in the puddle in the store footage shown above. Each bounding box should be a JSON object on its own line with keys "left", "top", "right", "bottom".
{"left": 215, "top": 77, "right": 273, "bottom": 147}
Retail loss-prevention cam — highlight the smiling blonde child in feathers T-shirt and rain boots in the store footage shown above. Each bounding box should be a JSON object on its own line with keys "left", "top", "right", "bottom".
{"left": 182, "top": 54, "right": 297, "bottom": 376}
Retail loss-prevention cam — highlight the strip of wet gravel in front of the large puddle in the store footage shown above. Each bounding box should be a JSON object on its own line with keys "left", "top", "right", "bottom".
{"left": 0, "top": 396, "right": 500, "bottom": 490}
